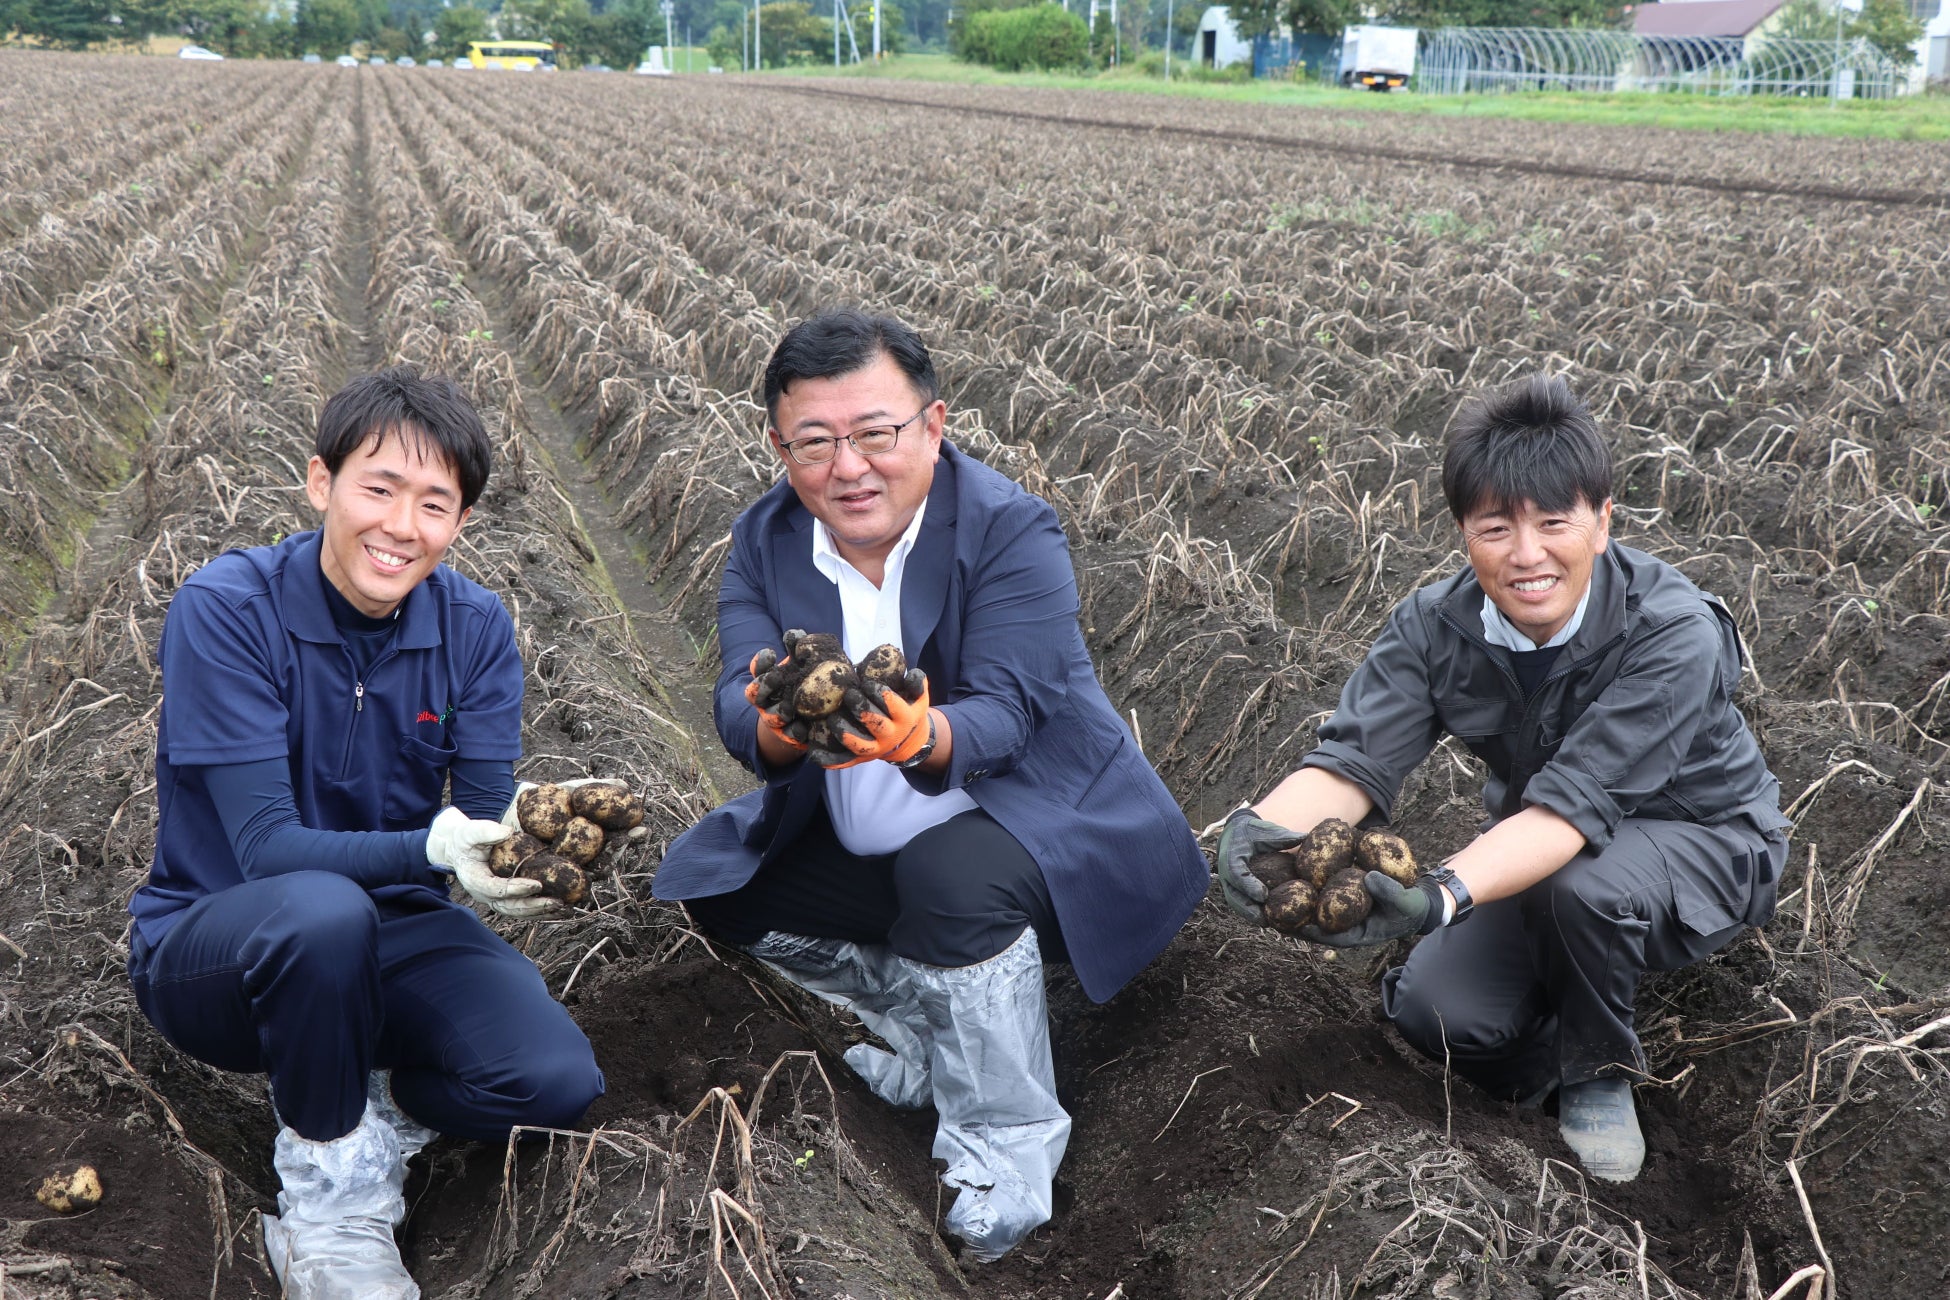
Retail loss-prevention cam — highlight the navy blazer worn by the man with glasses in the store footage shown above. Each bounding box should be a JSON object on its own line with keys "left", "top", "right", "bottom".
{"left": 655, "top": 442, "right": 1211, "bottom": 1002}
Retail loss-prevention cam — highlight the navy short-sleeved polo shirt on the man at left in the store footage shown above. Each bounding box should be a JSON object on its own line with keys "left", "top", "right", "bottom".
{"left": 129, "top": 532, "right": 523, "bottom": 943}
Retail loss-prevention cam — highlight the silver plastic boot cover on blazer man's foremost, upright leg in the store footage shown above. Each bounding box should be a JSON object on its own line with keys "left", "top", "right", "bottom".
{"left": 907, "top": 930, "right": 1071, "bottom": 1263}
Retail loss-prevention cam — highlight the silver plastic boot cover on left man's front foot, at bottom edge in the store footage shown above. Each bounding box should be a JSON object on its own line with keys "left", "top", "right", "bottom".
{"left": 263, "top": 1105, "right": 419, "bottom": 1300}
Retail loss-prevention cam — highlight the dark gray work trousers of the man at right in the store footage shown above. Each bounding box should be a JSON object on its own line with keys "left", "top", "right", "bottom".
{"left": 1381, "top": 819, "right": 1788, "bottom": 1099}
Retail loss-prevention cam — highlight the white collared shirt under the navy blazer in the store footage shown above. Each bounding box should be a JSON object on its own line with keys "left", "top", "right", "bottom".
{"left": 813, "top": 501, "right": 979, "bottom": 858}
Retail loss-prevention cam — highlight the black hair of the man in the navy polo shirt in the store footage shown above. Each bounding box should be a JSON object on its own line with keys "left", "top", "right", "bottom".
{"left": 312, "top": 366, "right": 493, "bottom": 511}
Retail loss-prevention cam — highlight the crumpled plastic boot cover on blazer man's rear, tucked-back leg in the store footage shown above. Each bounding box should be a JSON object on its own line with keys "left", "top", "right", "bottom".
{"left": 745, "top": 930, "right": 934, "bottom": 1111}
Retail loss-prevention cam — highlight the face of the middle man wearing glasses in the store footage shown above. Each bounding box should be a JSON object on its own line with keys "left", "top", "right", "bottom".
{"left": 772, "top": 353, "right": 948, "bottom": 583}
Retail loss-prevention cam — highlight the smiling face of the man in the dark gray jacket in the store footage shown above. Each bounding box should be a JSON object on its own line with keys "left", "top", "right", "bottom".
{"left": 1463, "top": 499, "right": 1611, "bottom": 645}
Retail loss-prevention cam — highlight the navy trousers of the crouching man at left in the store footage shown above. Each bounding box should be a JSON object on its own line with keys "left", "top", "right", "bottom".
{"left": 129, "top": 871, "right": 603, "bottom": 1142}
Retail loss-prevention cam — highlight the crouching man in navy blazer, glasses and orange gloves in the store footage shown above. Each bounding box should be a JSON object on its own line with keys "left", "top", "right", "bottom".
{"left": 655, "top": 310, "right": 1209, "bottom": 1261}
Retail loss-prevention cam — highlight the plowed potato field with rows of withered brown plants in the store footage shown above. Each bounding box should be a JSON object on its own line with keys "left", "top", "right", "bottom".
{"left": 0, "top": 53, "right": 1950, "bottom": 1300}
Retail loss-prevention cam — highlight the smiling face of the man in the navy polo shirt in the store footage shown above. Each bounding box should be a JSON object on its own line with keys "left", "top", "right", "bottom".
{"left": 304, "top": 422, "right": 470, "bottom": 618}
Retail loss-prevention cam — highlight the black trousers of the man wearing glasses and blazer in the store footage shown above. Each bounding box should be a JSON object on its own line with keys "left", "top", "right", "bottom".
{"left": 684, "top": 805, "right": 1069, "bottom": 967}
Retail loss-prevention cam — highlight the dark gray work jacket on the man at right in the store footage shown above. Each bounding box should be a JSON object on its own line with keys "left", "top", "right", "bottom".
{"left": 1301, "top": 542, "right": 1788, "bottom": 910}
